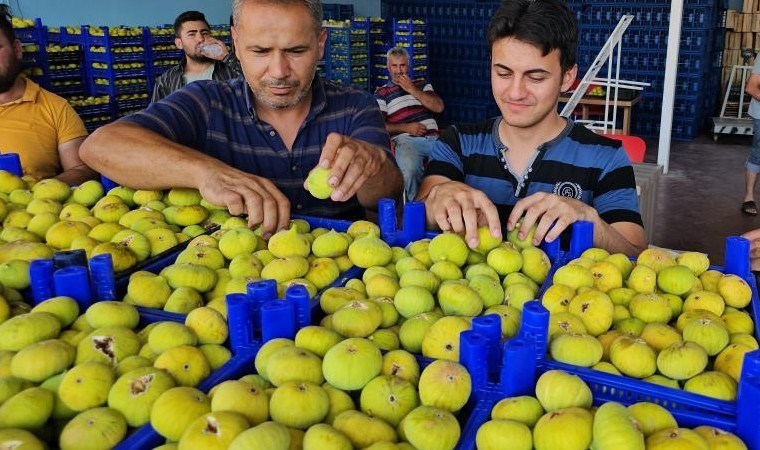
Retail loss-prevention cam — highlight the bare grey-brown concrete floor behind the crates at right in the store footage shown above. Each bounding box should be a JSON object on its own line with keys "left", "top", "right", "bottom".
{"left": 645, "top": 133, "right": 760, "bottom": 265}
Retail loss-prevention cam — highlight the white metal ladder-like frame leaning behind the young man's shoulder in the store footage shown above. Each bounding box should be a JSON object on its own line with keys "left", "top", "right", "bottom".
{"left": 560, "top": 14, "right": 649, "bottom": 132}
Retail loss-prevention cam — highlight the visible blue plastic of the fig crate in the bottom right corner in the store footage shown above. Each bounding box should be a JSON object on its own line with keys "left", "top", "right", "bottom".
{"left": 457, "top": 330, "right": 760, "bottom": 450}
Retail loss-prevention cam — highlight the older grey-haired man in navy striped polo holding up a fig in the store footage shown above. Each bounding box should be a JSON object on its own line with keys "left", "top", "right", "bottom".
{"left": 81, "top": 0, "right": 402, "bottom": 236}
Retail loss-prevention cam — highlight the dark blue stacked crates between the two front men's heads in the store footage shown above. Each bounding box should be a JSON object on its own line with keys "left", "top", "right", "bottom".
{"left": 382, "top": 0, "right": 499, "bottom": 125}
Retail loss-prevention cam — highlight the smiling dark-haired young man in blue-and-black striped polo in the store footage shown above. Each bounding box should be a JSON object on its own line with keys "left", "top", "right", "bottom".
{"left": 417, "top": 0, "right": 646, "bottom": 256}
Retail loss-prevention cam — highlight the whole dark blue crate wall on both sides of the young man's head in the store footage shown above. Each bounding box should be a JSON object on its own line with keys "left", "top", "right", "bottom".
{"left": 382, "top": 0, "right": 727, "bottom": 134}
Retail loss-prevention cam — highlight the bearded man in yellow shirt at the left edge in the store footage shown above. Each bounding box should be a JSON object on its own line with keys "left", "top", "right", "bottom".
{"left": 0, "top": 5, "right": 97, "bottom": 184}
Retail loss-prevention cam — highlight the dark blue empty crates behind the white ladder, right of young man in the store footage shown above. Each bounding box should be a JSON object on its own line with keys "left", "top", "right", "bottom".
{"left": 568, "top": 0, "right": 726, "bottom": 140}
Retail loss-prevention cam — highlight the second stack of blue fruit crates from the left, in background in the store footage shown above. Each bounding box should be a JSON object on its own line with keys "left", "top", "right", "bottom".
{"left": 46, "top": 27, "right": 87, "bottom": 98}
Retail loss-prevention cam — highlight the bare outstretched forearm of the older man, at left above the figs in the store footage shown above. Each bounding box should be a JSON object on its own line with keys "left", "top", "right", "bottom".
{"left": 79, "top": 122, "right": 212, "bottom": 189}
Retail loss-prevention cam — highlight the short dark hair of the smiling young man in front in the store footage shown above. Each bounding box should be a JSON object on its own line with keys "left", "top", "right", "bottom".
{"left": 486, "top": 0, "right": 578, "bottom": 72}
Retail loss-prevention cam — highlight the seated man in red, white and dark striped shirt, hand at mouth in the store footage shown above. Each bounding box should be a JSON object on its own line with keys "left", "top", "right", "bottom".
{"left": 375, "top": 47, "right": 443, "bottom": 200}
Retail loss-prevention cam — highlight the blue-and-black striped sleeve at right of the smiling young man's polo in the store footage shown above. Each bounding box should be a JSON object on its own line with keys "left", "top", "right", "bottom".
{"left": 594, "top": 147, "right": 643, "bottom": 226}
